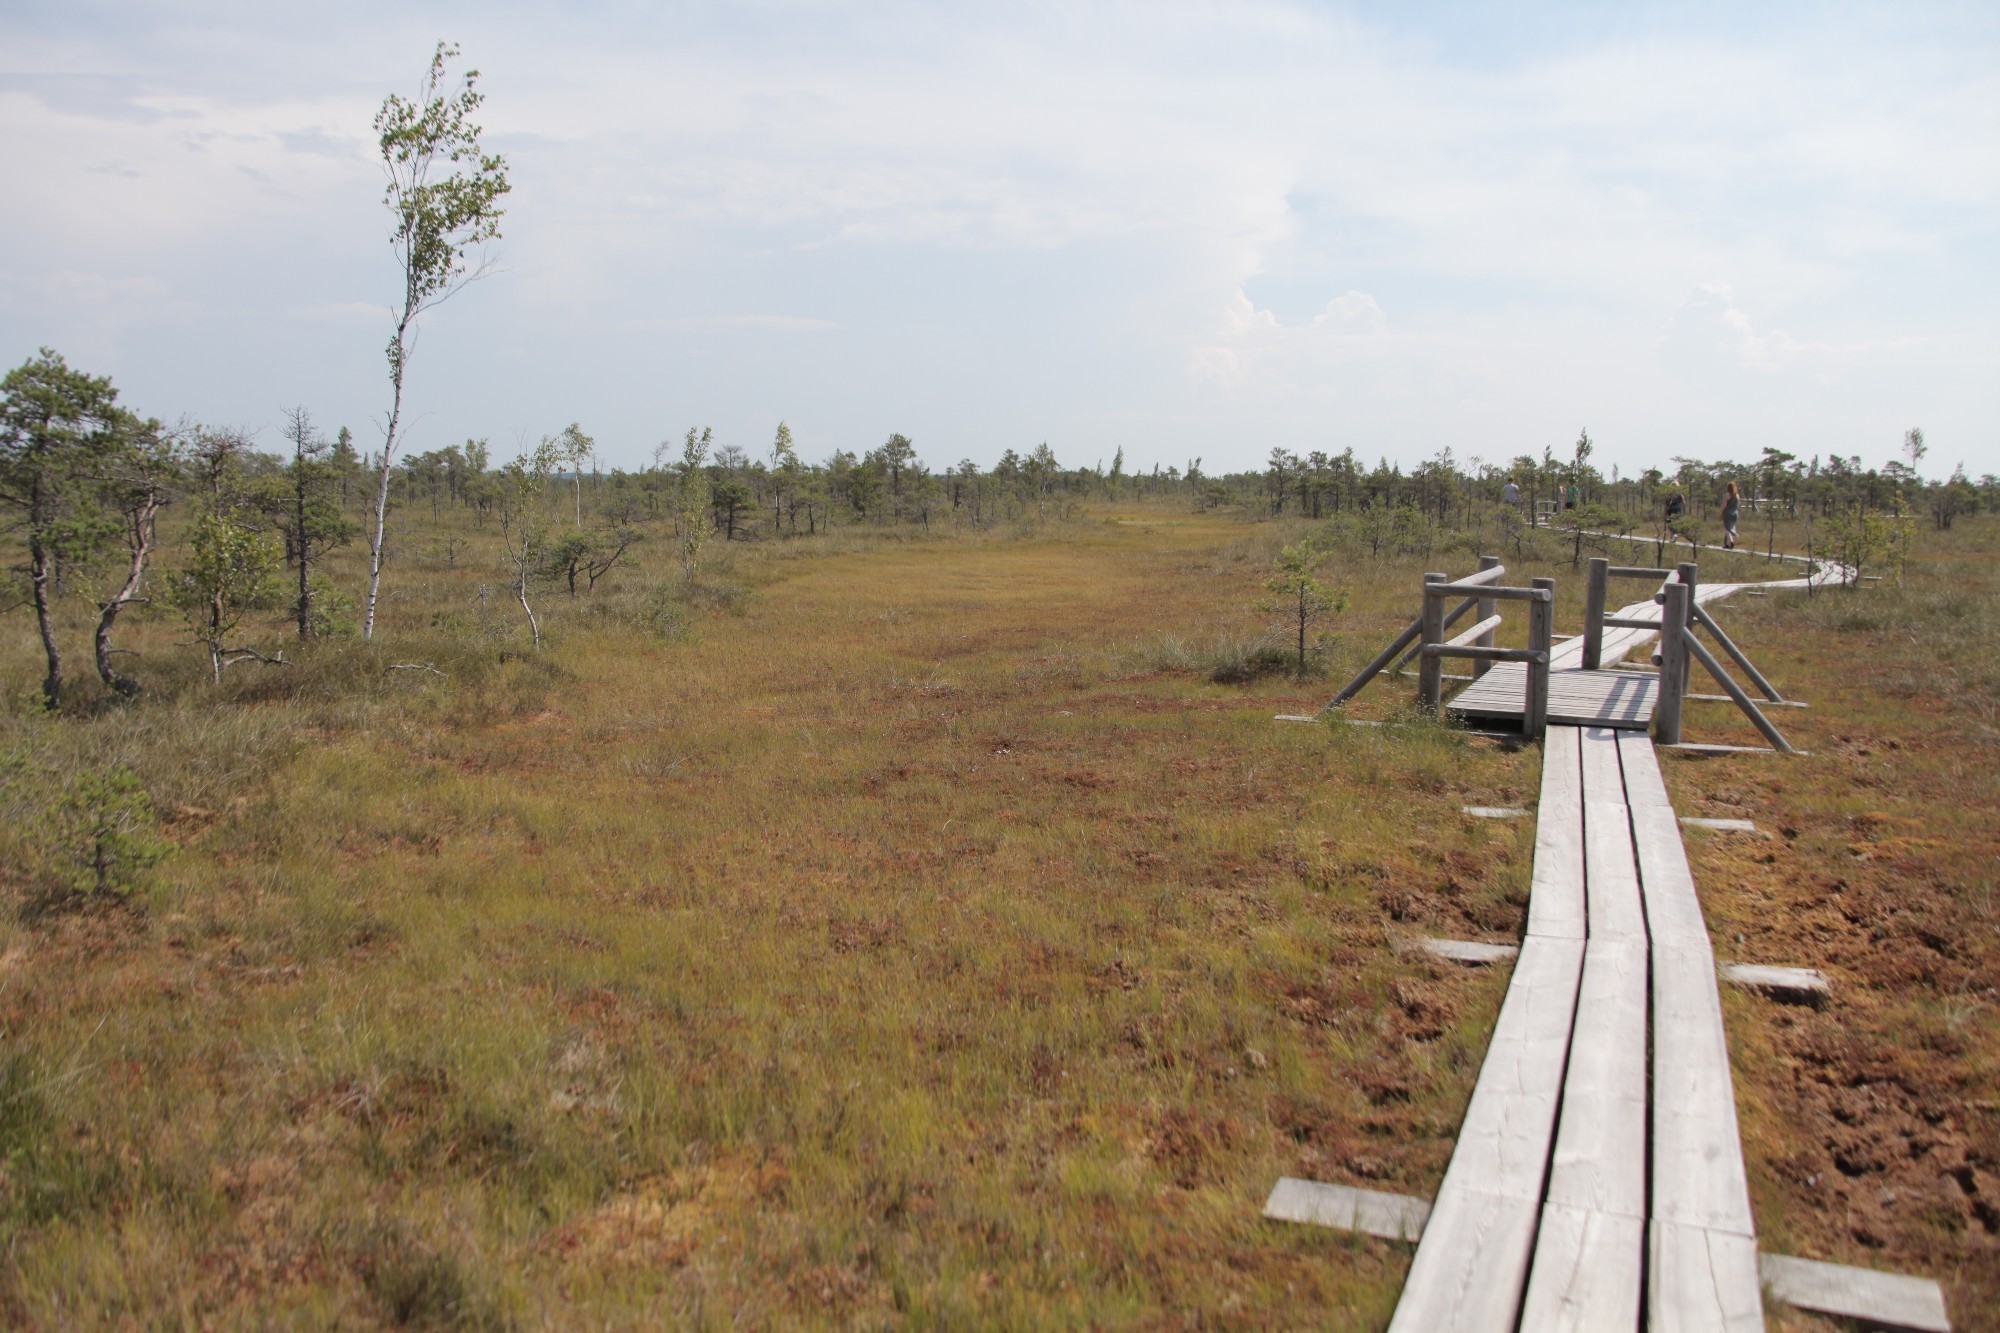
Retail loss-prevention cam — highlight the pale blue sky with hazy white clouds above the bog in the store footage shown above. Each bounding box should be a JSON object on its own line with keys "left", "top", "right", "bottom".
{"left": 0, "top": 0, "right": 2000, "bottom": 476}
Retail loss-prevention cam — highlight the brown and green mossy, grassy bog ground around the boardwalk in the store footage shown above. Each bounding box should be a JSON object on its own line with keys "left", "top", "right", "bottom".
{"left": 0, "top": 508, "right": 2000, "bottom": 1329}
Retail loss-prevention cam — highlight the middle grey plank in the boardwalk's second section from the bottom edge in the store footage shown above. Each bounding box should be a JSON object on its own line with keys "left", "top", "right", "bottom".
{"left": 1546, "top": 923, "right": 1646, "bottom": 1216}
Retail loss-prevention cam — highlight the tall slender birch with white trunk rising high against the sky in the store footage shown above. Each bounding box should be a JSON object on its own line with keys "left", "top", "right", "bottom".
{"left": 362, "top": 42, "right": 512, "bottom": 638}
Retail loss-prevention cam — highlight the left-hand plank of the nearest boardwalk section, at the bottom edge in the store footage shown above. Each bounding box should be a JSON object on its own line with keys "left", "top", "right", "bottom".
{"left": 1388, "top": 1179, "right": 1540, "bottom": 1333}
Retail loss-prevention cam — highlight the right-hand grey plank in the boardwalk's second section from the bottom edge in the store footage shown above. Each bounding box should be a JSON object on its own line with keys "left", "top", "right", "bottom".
{"left": 1652, "top": 941, "right": 1756, "bottom": 1239}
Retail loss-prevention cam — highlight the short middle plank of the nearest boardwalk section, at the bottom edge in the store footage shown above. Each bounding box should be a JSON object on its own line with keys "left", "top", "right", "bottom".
{"left": 1520, "top": 1203, "right": 1646, "bottom": 1333}
